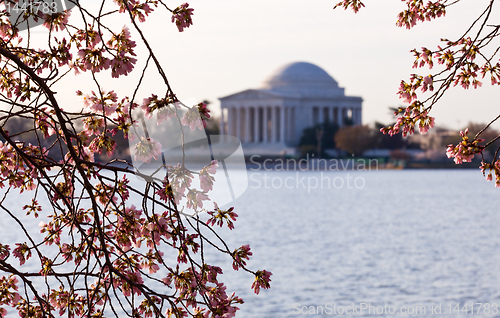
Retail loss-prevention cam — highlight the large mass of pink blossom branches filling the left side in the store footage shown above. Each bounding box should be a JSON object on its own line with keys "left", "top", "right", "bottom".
{"left": 0, "top": 0, "right": 271, "bottom": 317}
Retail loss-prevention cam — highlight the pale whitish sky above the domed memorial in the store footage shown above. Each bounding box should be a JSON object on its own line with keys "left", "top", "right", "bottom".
{"left": 28, "top": 0, "right": 500, "bottom": 129}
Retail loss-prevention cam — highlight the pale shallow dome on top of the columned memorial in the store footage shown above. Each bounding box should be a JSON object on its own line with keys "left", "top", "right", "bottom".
{"left": 261, "top": 62, "right": 344, "bottom": 98}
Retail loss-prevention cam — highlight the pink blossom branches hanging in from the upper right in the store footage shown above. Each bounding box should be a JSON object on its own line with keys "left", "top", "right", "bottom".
{"left": 336, "top": 0, "right": 500, "bottom": 181}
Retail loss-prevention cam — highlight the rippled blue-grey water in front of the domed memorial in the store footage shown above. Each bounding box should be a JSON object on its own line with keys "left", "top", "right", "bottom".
{"left": 2, "top": 169, "right": 500, "bottom": 318}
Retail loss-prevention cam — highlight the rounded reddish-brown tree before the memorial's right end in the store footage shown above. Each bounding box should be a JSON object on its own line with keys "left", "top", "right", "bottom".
{"left": 335, "top": 125, "right": 376, "bottom": 156}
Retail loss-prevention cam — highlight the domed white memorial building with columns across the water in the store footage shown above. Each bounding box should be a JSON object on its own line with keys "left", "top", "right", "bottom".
{"left": 219, "top": 62, "right": 363, "bottom": 155}
